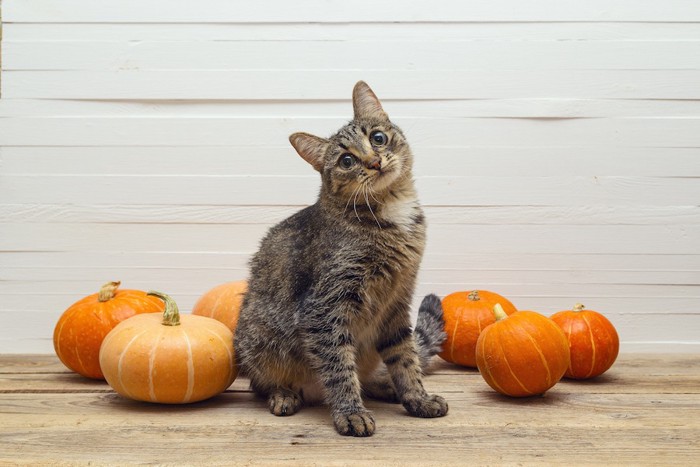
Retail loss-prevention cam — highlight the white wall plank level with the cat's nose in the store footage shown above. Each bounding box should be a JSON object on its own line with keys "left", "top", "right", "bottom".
{"left": 0, "top": 145, "right": 700, "bottom": 178}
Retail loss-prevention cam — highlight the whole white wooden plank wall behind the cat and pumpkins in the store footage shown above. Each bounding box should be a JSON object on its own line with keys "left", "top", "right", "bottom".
{"left": 0, "top": 0, "right": 700, "bottom": 353}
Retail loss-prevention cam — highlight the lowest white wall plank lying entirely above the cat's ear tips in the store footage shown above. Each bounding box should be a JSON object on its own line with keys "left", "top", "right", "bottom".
{"left": 3, "top": 36, "right": 700, "bottom": 72}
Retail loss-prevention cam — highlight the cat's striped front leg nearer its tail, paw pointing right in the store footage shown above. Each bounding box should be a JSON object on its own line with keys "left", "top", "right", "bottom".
{"left": 377, "top": 303, "right": 448, "bottom": 418}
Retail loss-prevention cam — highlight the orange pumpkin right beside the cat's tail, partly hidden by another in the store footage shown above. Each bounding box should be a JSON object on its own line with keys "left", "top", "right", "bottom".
{"left": 439, "top": 290, "right": 516, "bottom": 368}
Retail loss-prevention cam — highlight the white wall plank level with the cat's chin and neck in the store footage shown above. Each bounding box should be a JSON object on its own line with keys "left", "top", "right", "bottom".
{"left": 0, "top": 173, "right": 700, "bottom": 207}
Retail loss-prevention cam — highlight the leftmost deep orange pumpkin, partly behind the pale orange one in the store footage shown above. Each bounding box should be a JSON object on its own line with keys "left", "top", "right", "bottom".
{"left": 53, "top": 282, "right": 163, "bottom": 379}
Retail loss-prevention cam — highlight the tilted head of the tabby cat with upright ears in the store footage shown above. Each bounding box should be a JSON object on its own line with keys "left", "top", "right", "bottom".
{"left": 289, "top": 81, "right": 413, "bottom": 199}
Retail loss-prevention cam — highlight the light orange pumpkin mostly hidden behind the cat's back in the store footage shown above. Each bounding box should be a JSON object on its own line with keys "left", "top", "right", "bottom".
{"left": 192, "top": 281, "right": 248, "bottom": 332}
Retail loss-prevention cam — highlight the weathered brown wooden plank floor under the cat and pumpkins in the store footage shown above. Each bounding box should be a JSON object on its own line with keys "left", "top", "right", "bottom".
{"left": 0, "top": 355, "right": 700, "bottom": 465}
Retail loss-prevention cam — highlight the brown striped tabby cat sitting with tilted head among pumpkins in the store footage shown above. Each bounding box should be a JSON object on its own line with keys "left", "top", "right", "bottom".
{"left": 234, "top": 81, "right": 448, "bottom": 436}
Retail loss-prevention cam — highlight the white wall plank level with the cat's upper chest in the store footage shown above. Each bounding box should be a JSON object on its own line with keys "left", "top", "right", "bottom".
{"left": 0, "top": 223, "right": 700, "bottom": 254}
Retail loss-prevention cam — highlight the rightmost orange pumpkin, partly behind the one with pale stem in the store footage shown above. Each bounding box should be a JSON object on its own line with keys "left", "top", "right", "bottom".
{"left": 552, "top": 303, "right": 620, "bottom": 379}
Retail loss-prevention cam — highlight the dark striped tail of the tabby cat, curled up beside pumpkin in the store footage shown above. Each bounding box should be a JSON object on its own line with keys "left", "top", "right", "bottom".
{"left": 414, "top": 294, "right": 447, "bottom": 372}
